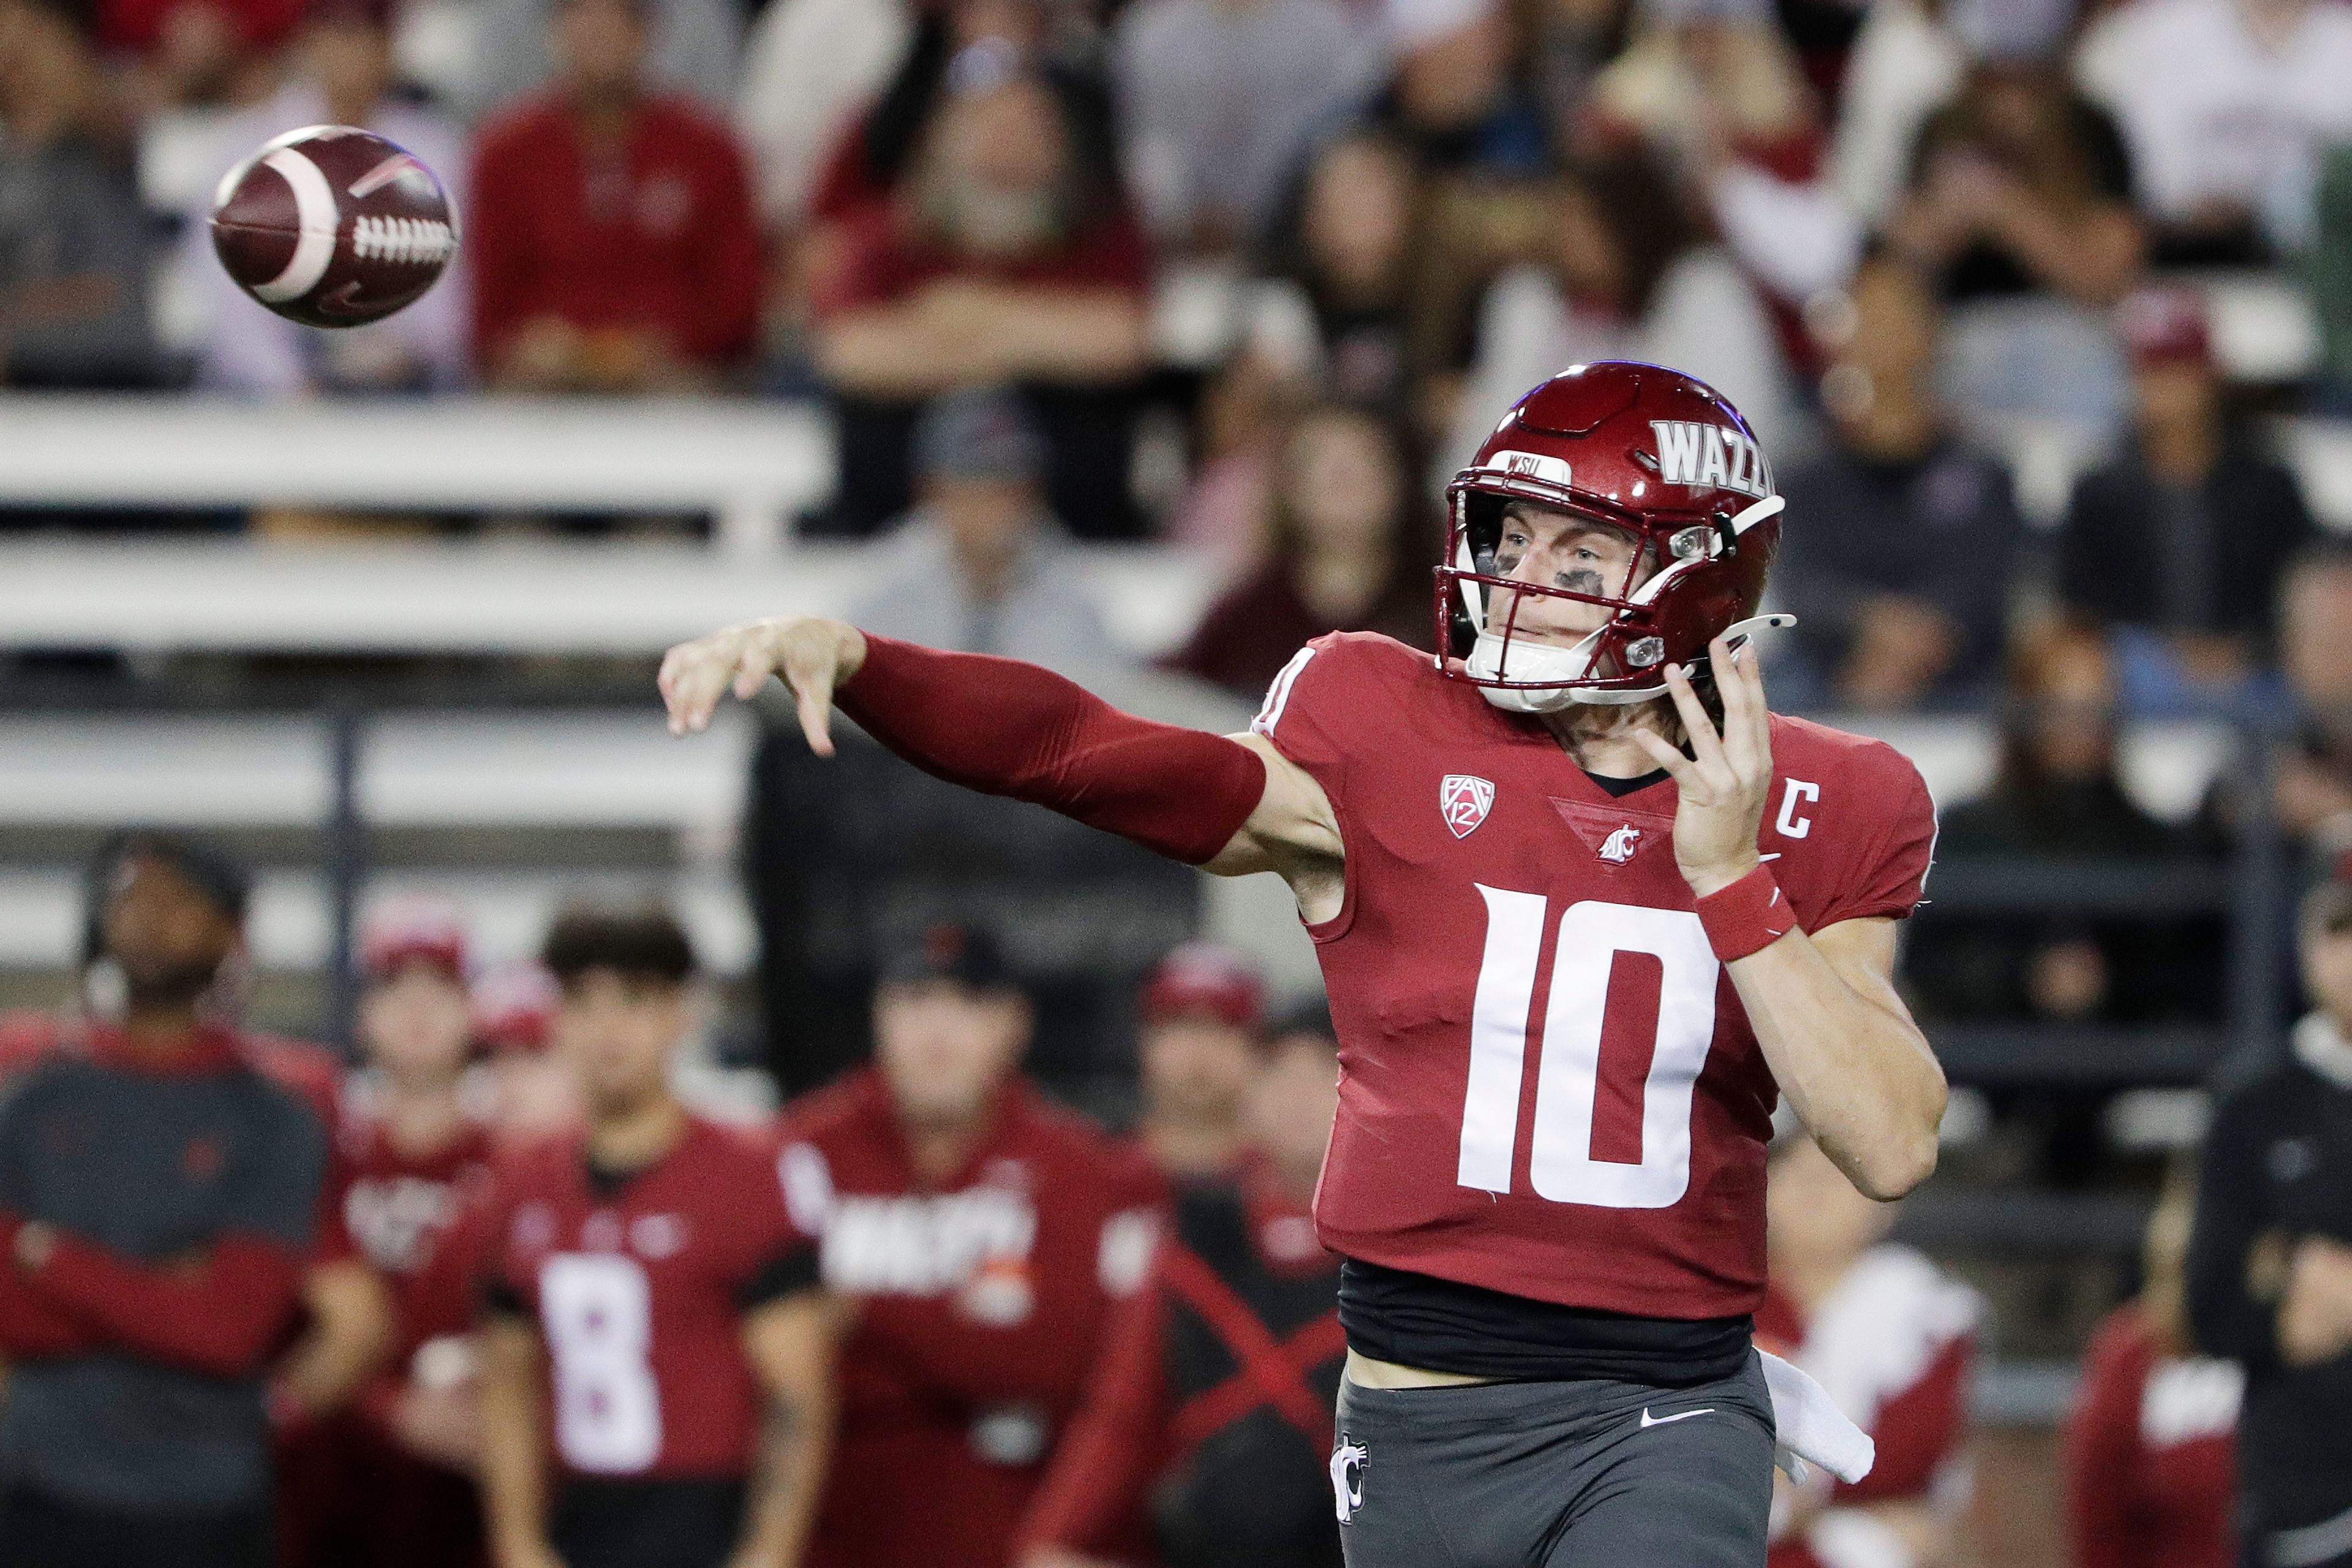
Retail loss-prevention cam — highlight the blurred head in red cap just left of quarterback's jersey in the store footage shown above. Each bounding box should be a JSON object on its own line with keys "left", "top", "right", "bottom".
{"left": 1136, "top": 943, "right": 1265, "bottom": 1180}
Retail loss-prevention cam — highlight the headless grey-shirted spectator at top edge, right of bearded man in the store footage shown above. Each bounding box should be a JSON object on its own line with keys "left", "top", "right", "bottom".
{"left": 1112, "top": 0, "right": 1369, "bottom": 254}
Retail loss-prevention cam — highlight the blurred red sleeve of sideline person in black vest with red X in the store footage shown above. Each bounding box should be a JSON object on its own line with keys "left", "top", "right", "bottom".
{"left": 1011, "top": 1279, "right": 1169, "bottom": 1561}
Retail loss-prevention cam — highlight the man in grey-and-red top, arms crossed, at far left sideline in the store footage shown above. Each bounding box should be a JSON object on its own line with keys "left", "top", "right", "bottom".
{"left": 0, "top": 835, "right": 327, "bottom": 1568}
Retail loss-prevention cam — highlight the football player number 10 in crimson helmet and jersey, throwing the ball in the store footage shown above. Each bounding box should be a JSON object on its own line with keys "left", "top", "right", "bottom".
{"left": 661, "top": 362, "right": 1945, "bottom": 1568}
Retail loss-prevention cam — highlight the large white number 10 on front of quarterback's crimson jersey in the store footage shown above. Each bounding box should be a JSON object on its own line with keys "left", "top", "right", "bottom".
{"left": 1456, "top": 884, "right": 1722, "bottom": 1208}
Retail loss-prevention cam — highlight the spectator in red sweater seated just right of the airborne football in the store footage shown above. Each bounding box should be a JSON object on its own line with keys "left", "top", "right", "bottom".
{"left": 466, "top": 0, "right": 760, "bottom": 393}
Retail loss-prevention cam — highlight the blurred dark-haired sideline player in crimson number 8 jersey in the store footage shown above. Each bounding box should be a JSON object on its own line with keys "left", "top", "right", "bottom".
{"left": 468, "top": 912, "right": 835, "bottom": 1568}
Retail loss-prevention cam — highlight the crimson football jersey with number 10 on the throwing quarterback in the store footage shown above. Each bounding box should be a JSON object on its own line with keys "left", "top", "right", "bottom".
{"left": 1251, "top": 632, "right": 1936, "bottom": 1319}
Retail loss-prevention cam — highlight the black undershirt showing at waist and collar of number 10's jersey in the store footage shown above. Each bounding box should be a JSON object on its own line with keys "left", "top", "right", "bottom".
{"left": 1338, "top": 769, "right": 1755, "bottom": 1387}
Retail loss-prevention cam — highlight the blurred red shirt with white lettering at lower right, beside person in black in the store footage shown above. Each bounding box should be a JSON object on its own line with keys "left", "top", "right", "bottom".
{"left": 2065, "top": 1302, "right": 2246, "bottom": 1568}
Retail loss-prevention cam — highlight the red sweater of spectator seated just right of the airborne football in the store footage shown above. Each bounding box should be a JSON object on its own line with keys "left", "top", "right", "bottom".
{"left": 466, "top": 99, "right": 760, "bottom": 364}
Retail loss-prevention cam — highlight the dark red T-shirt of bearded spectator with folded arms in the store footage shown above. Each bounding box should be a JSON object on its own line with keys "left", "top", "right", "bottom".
{"left": 814, "top": 200, "right": 1153, "bottom": 315}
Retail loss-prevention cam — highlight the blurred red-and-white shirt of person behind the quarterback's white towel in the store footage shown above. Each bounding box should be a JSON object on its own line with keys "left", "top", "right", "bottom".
{"left": 1757, "top": 1243, "right": 1983, "bottom": 1568}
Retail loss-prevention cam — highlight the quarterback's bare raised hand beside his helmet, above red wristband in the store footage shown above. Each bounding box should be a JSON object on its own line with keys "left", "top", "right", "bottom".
{"left": 1635, "top": 637, "right": 1771, "bottom": 898}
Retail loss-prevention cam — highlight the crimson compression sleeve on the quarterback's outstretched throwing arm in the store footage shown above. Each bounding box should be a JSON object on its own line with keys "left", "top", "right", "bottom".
{"left": 837, "top": 635, "right": 1265, "bottom": 865}
